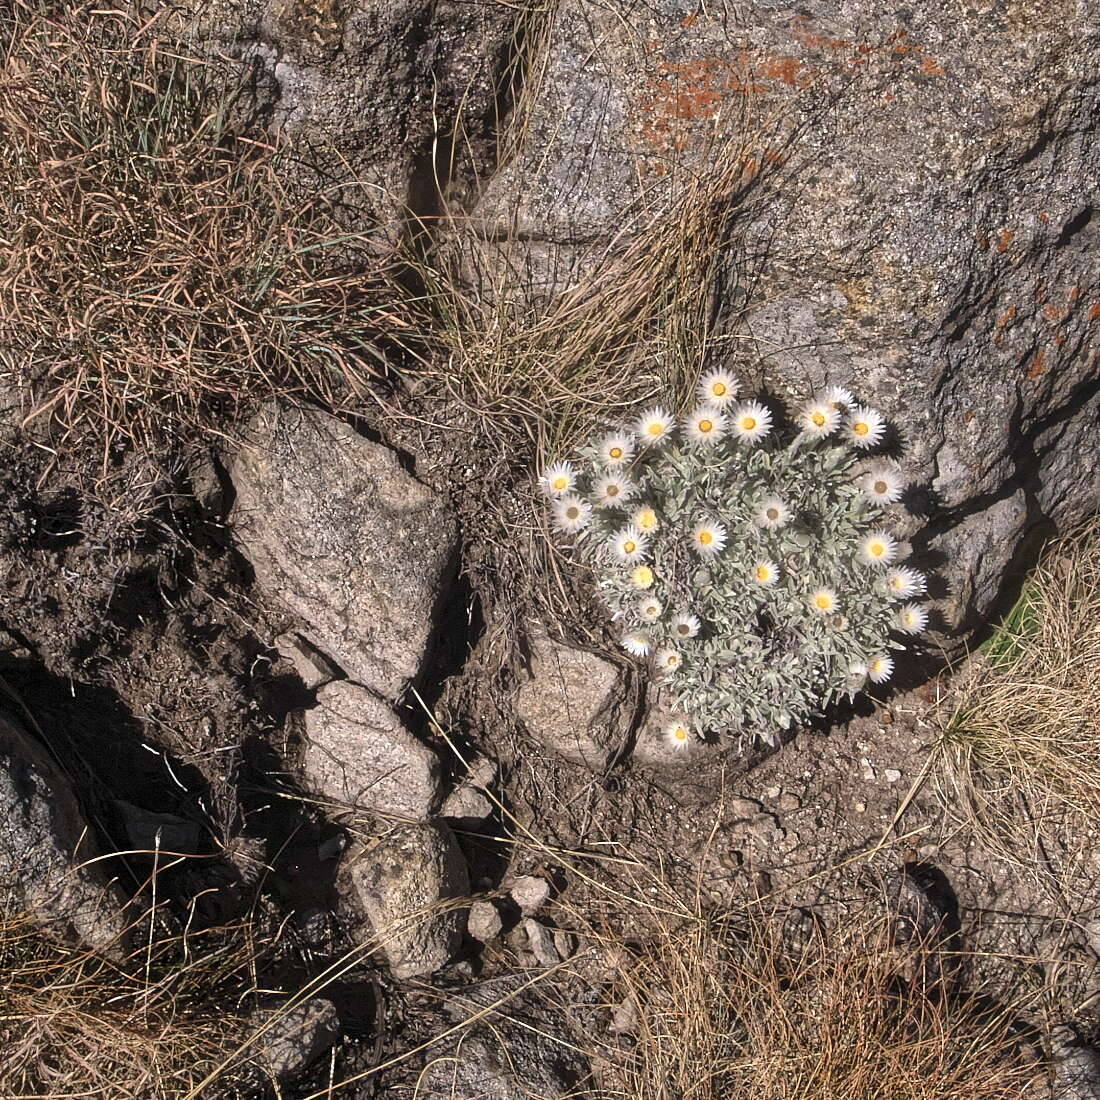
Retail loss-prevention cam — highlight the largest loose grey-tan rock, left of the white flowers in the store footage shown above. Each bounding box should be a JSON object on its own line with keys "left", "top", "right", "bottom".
{"left": 230, "top": 404, "right": 458, "bottom": 699}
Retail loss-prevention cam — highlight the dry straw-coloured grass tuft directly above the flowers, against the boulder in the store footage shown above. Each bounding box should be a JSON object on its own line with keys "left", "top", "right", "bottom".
{"left": 419, "top": 123, "right": 774, "bottom": 460}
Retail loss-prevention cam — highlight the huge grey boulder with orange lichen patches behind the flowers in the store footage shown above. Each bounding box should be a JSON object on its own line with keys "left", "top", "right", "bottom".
{"left": 475, "top": 0, "right": 1100, "bottom": 630}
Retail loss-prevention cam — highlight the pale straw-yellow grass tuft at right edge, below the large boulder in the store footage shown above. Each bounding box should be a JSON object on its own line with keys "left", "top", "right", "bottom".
{"left": 938, "top": 521, "right": 1100, "bottom": 880}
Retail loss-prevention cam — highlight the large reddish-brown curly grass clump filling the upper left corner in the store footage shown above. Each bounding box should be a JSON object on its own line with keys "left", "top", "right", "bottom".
{"left": 0, "top": 0, "right": 396, "bottom": 465}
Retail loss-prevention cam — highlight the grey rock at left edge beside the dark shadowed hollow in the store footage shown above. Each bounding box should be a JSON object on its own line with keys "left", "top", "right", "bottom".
{"left": 0, "top": 714, "right": 127, "bottom": 954}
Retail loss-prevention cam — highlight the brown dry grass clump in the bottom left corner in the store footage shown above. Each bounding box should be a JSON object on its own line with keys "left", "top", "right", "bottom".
{"left": 0, "top": 911, "right": 254, "bottom": 1100}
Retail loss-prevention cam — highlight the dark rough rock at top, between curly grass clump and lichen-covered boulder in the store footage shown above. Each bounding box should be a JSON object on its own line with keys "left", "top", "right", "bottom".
{"left": 174, "top": 0, "right": 523, "bottom": 232}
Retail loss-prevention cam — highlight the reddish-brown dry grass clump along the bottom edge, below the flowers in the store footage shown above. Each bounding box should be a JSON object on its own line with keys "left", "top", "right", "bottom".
{"left": 602, "top": 919, "right": 1035, "bottom": 1100}
